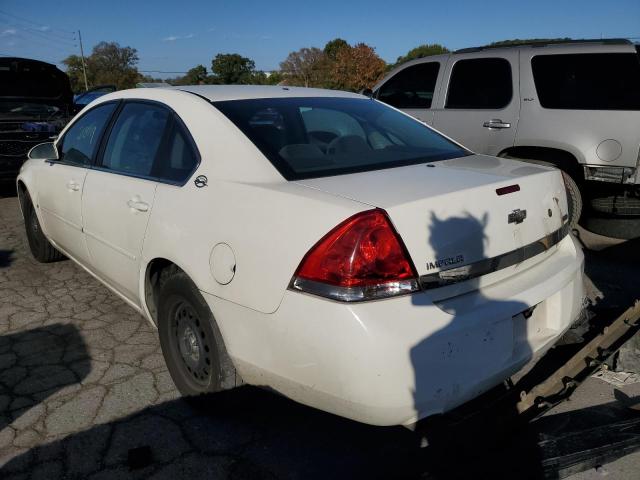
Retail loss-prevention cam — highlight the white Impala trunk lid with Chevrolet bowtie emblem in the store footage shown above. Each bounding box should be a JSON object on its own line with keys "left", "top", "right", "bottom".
{"left": 297, "top": 155, "right": 567, "bottom": 284}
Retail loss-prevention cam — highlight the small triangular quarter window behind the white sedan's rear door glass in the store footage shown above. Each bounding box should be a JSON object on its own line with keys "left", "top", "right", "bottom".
{"left": 152, "top": 120, "right": 198, "bottom": 183}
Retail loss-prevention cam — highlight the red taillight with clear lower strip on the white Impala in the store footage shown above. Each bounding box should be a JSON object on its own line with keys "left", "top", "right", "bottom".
{"left": 291, "top": 209, "right": 418, "bottom": 302}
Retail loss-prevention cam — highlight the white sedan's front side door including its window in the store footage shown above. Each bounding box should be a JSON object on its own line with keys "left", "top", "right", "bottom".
{"left": 38, "top": 102, "right": 117, "bottom": 263}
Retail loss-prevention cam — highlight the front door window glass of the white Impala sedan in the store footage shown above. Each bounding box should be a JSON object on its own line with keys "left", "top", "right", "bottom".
{"left": 60, "top": 103, "right": 117, "bottom": 166}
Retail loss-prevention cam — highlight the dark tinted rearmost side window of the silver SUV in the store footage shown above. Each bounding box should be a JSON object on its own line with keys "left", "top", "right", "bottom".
{"left": 531, "top": 53, "right": 640, "bottom": 110}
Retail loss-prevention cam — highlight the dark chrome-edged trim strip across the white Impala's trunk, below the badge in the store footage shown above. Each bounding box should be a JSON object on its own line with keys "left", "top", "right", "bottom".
{"left": 420, "top": 223, "right": 569, "bottom": 290}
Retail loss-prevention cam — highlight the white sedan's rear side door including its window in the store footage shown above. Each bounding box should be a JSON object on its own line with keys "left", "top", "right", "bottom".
{"left": 82, "top": 101, "right": 172, "bottom": 305}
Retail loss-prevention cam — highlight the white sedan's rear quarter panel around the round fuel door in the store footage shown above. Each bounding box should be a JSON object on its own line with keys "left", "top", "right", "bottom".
{"left": 140, "top": 92, "right": 369, "bottom": 314}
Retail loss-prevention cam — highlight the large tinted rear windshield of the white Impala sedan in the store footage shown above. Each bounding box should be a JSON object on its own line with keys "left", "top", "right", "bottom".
{"left": 214, "top": 97, "right": 468, "bottom": 180}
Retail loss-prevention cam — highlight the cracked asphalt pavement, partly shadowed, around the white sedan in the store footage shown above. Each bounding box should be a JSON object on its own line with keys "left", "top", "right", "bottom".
{"left": 0, "top": 193, "right": 640, "bottom": 480}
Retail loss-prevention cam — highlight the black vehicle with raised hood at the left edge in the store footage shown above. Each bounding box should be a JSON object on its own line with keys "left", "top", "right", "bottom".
{"left": 0, "top": 57, "right": 73, "bottom": 183}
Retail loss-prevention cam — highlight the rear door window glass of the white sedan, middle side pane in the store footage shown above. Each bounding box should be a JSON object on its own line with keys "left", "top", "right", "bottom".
{"left": 102, "top": 103, "right": 171, "bottom": 177}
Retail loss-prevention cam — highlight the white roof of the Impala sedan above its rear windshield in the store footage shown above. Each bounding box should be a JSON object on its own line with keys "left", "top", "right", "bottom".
{"left": 171, "top": 85, "right": 366, "bottom": 102}
